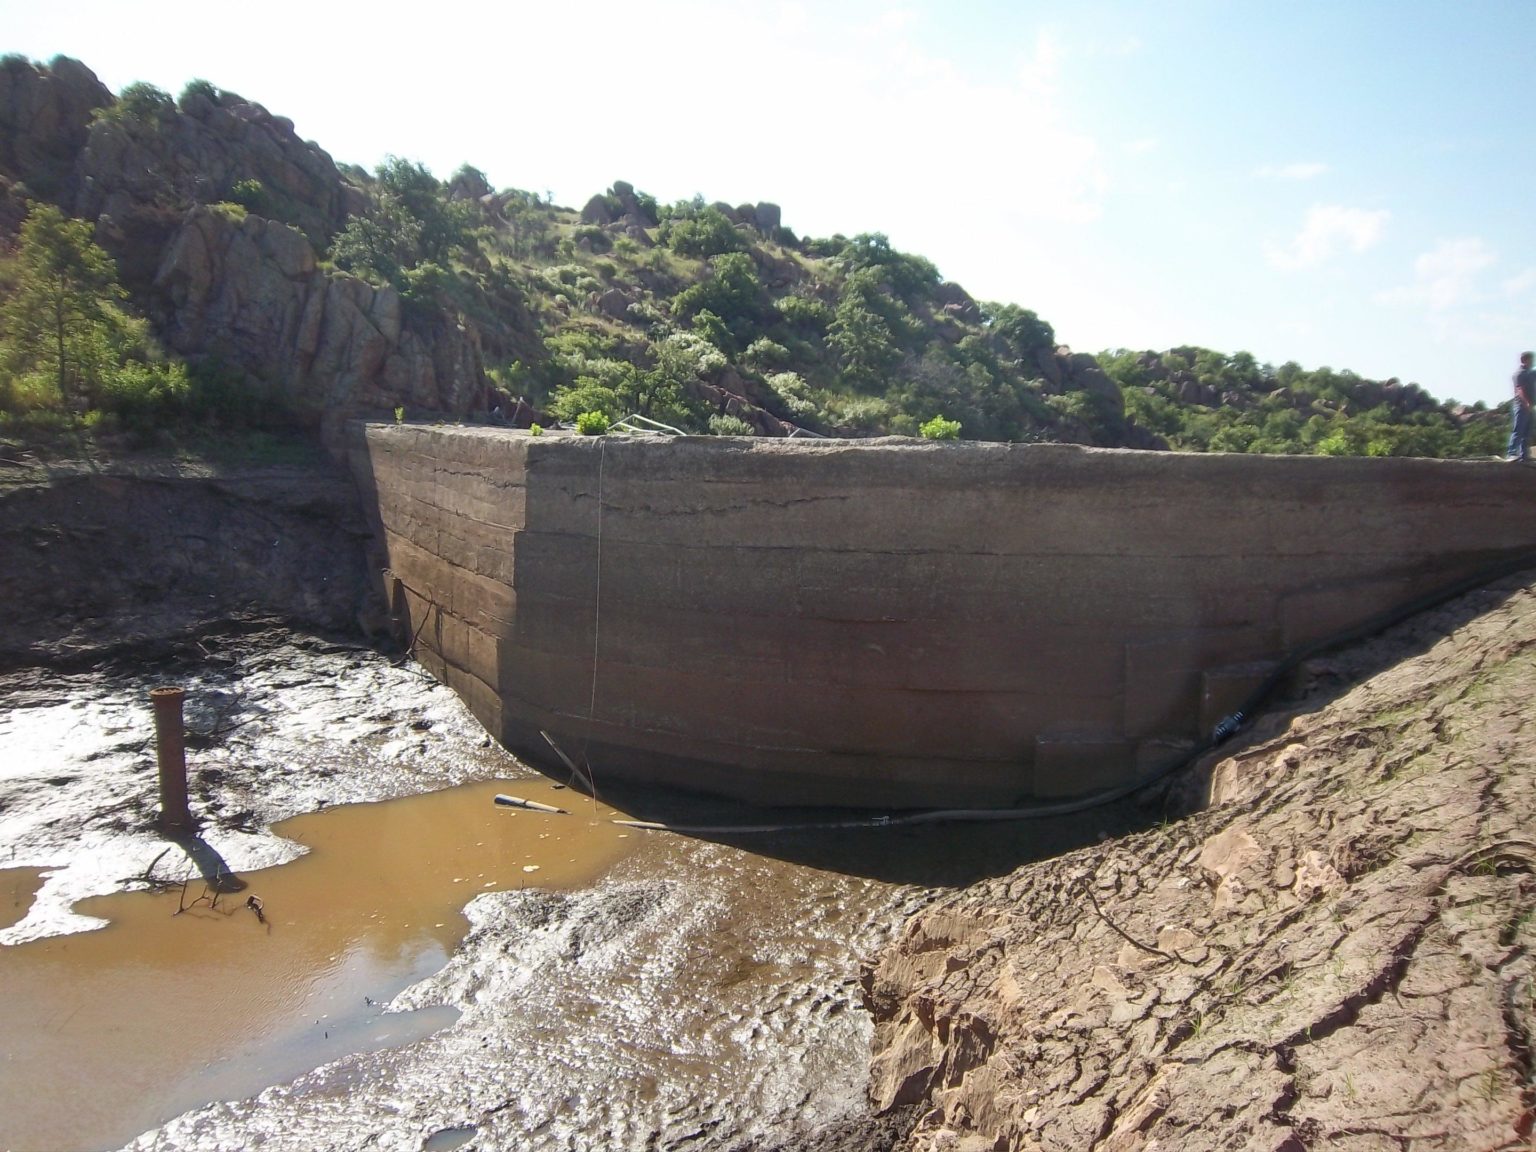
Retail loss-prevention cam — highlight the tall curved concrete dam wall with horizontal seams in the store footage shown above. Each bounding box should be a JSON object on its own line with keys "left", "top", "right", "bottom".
{"left": 350, "top": 424, "right": 1536, "bottom": 808}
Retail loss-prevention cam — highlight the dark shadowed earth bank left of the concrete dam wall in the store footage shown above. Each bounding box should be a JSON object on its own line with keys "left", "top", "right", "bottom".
{"left": 0, "top": 461, "right": 381, "bottom": 667}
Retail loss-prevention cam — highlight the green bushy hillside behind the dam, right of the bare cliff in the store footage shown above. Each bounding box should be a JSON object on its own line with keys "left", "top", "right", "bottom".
{"left": 308, "top": 161, "right": 1504, "bottom": 456}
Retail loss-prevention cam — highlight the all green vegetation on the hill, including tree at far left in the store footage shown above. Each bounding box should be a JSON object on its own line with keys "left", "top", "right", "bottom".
{"left": 0, "top": 58, "right": 1504, "bottom": 456}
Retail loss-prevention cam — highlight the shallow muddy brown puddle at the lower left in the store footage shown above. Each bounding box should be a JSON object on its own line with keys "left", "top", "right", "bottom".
{"left": 0, "top": 779, "right": 637, "bottom": 1149}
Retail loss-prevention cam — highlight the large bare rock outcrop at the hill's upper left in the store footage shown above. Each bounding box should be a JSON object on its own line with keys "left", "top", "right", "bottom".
{"left": 0, "top": 57, "right": 485, "bottom": 421}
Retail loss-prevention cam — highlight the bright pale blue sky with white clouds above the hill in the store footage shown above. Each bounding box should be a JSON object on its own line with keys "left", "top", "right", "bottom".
{"left": 9, "top": 0, "right": 1536, "bottom": 404}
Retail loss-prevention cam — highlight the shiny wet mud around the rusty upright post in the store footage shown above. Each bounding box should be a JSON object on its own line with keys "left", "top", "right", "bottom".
{"left": 0, "top": 627, "right": 503, "bottom": 945}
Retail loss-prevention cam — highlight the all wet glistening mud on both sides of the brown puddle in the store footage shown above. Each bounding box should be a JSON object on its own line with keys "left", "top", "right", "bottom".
{"left": 0, "top": 631, "right": 1121, "bottom": 1150}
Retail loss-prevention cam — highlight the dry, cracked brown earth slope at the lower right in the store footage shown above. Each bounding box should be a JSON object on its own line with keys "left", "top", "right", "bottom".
{"left": 866, "top": 574, "right": 1536, "bottom": 1152}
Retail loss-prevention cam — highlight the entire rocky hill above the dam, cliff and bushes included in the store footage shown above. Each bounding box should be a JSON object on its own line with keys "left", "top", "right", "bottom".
{"left": 0, "top": 55, "right": 1499, "bottom": 455}
